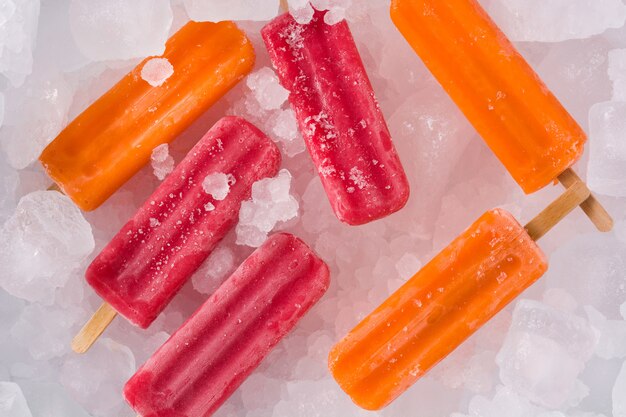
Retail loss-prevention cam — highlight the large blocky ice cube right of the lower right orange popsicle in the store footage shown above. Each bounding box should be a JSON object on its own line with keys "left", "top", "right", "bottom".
{"left": 496, "top": 299, "right": 596, "bottom": 408}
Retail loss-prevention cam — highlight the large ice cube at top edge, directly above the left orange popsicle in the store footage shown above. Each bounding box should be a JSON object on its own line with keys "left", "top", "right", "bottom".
{"left": 70, "top": 0, "right": 173, "bottom": 61}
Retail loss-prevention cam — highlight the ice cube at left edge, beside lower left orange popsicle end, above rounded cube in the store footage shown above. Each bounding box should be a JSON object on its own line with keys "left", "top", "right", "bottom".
{"left": 0, "top": 73, "right": 74, "bottom": 169}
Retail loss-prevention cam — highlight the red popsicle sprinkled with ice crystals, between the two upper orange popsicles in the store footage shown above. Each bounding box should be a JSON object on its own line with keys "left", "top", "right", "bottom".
{"left": 262, "top": 11, "right": 409, "bottom": 225}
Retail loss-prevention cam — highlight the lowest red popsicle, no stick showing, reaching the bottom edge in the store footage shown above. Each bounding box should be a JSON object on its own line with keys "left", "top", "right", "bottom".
{"left": 124, "top": 233, "right": 329, "bottom": 417}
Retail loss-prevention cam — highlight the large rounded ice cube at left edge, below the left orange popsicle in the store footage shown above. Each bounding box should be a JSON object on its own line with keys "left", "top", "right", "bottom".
{"left": 0, "top": 191, "right": 95, "bottom": 304}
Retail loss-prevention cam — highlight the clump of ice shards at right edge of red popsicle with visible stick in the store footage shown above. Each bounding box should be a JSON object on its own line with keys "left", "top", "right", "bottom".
{"left": 236, "top": 169, "right": 299, "bottom": 247}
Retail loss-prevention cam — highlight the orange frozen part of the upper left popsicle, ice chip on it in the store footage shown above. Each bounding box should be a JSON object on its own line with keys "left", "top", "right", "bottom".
{"left": 40, "top": 22, "right": 255, "bottom": 210}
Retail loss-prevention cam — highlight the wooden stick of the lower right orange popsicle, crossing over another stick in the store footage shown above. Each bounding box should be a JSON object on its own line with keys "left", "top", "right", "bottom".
{"left": 524, "top": 181, "right": 591, "bottom": 241}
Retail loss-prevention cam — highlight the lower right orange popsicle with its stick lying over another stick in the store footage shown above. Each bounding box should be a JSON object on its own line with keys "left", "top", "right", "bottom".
{"left": 329, "top": 178, "right": 589, "bottom": 410}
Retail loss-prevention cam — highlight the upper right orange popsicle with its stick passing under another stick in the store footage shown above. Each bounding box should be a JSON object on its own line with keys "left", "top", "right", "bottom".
{"left": 391, "top": 0, "right": 612, "bottom": 231}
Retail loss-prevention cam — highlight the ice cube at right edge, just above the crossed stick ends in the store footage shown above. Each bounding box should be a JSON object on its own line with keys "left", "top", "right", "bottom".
{"left": 587, "top": 101, "right": 626, "bottom": 197}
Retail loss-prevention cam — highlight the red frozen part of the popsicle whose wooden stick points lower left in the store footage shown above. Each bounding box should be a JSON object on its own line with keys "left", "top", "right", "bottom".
{"left": 72, "top": 117, "right": 280, "bottom": 352}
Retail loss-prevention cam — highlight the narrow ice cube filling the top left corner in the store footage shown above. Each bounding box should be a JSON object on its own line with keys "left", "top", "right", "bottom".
{"left": 0, "top": 0, "right": 40, "bottom": 87}
